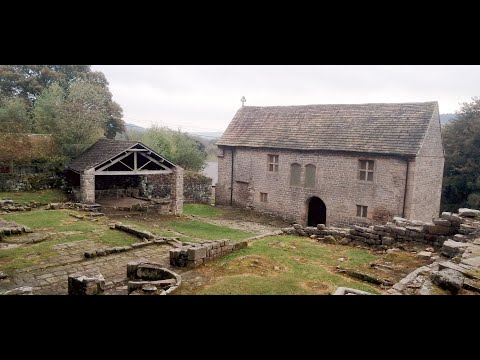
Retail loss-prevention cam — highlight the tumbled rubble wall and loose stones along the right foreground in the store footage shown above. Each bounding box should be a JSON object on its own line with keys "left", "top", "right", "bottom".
{"left": 316, "top": 208, "right": 480, "bottom": 295}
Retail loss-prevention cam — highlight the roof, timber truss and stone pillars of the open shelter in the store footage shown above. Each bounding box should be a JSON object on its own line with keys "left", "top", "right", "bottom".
{"left": 67, "top": 139, "right": 183, "bottom": 215}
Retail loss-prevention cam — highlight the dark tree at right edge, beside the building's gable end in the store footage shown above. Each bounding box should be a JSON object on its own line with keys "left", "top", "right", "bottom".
{"left": 442, "top": 98, "right": 480, "bottom": 211}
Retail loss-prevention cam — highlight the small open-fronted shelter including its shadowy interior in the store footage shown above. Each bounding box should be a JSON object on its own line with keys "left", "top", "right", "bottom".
{"left": 67, "top": 139, "right": 183, "bottom": 215}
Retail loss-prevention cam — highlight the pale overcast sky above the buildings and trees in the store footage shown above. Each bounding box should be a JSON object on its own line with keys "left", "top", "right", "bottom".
{"left": 92, "top": 65, "right": 480, "bottom": 132}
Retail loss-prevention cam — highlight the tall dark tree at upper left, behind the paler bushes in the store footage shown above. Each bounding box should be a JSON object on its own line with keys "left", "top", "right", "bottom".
{"left": 0, "top": 65, "right": 125, "bottom": 139}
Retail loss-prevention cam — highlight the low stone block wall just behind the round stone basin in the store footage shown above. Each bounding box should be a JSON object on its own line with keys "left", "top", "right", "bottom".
{"left": 170, "top": 240, "right": 248, "bottom": 267}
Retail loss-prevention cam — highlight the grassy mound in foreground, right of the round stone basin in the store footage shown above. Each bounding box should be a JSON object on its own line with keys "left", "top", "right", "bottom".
{"left": 178, "top": 236, "right": 381, "bottom": 295}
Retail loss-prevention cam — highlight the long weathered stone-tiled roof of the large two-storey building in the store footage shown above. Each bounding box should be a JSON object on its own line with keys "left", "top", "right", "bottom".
{"left": 217, "top": 101, "right": 438, "bottom": 155}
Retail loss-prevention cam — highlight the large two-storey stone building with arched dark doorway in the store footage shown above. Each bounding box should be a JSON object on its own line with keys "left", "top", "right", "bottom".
{"left": 216, "top": 102, "right": 444, "bottom": 225}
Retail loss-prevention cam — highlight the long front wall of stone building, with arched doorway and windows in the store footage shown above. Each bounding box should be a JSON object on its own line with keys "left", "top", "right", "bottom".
{"left": 215, "top": 147, "right": 406, "bottom": 225}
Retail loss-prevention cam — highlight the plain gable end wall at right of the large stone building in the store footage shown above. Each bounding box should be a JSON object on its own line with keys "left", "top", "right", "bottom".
{"left": 409, "top": 108, "right": 445, "bottom": 221}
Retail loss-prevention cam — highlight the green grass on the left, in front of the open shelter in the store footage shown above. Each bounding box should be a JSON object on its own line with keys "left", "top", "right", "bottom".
{"left": 0, "top": 210, "right": 254, "bottom": 272}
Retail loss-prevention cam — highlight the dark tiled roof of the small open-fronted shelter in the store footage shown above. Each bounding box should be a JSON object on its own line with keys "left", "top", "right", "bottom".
{"left": 68, "top": 139, "right": 176, "bottom": 172}
